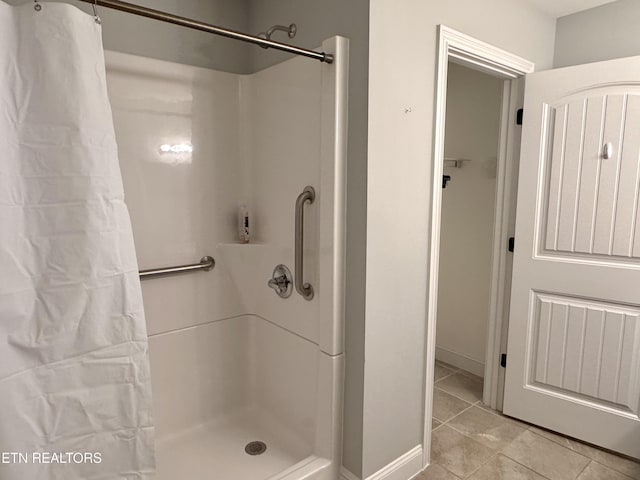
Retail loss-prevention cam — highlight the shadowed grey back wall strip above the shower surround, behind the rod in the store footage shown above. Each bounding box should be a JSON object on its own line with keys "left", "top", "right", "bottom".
{"left": 7, "top": 0, "right": 258, "bottom": 73}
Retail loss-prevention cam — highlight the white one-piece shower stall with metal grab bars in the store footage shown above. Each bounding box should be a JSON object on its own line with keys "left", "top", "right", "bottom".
{"left": 106, "top": 9, "right": 348, "bottom": 480}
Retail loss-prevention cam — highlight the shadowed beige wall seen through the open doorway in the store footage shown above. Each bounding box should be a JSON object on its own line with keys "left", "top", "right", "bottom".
{"left": 436, "top": 63, "right": 503, "bottom": 375}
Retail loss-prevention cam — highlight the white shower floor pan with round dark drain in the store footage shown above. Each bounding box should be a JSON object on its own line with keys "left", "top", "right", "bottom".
{"left": 156, "top": 411, "right": 310, "bottom": 480}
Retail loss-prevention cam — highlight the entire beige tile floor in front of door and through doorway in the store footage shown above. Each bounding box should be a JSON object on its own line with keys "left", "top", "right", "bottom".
{"left": 415, "top": 362, "right": 640, "bottom": 480}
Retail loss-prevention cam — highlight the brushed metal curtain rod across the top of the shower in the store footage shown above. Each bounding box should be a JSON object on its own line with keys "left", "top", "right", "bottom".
{"left": 80, "top": 0, "right": 333, "bottom": 63}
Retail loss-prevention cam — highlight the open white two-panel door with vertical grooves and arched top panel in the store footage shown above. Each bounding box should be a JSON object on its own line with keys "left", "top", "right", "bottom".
{"left": 504, "top": 57, "right": 640, "bottom": 458}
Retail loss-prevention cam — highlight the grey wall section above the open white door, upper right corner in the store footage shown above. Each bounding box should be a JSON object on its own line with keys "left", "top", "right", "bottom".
{"left": 554, "top": 0, "right": 640, "bottom": 68}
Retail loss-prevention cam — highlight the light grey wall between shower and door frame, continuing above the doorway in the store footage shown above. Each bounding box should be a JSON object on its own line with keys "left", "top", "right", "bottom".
{"left": 362, "top": 0, "right": 555, "bottom": 477}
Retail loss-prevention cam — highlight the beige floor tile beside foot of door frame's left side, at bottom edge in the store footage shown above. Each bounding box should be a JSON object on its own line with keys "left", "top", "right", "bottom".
{"left": 431, "top": 425, "right": 494, "bottom": 478}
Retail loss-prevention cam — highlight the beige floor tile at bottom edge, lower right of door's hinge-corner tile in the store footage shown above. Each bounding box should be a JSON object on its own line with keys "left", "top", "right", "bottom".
{"left": 504, "top": 429, "right": 590, "bottom": 480}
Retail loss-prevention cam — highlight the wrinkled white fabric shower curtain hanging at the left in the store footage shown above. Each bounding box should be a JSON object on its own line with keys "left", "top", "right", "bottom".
{"left": 0, "top": 1, "right": 154, "bottom": 480}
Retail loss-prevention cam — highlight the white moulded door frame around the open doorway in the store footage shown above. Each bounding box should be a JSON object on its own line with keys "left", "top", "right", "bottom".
{"left": 423, "top": 25, "right": 535, "bottom": 468}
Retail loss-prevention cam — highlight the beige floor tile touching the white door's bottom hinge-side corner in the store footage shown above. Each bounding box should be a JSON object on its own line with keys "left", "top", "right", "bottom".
{"left": 447, "top": 407, "right": 526, "bottom": 450}
